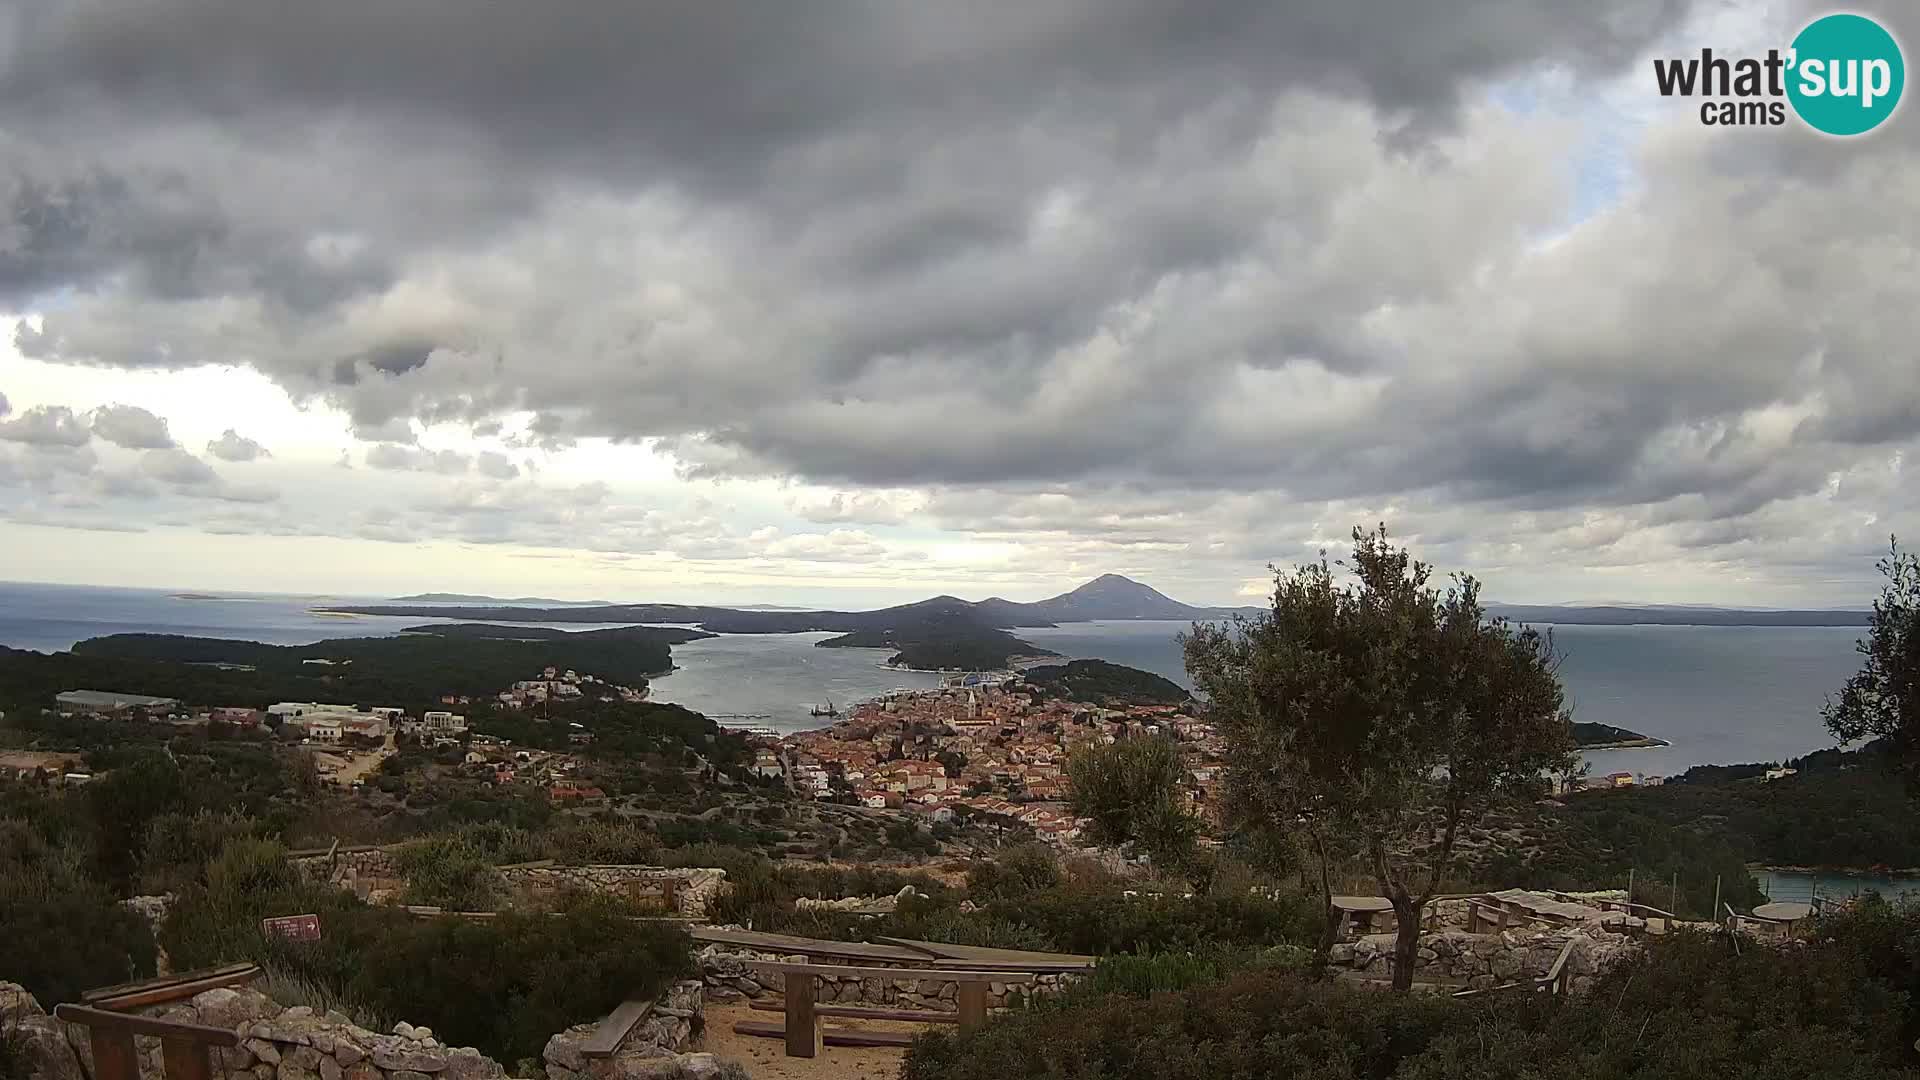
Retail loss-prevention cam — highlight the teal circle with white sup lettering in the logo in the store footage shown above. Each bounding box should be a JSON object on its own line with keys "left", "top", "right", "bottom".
{"left": 1788, "top": 13, "right": 1907, "bottom": 135}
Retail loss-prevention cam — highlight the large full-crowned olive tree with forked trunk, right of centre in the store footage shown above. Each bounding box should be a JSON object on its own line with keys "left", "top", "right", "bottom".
{"left": 1185, "top": 525, "right": 1574, "bottom": 990}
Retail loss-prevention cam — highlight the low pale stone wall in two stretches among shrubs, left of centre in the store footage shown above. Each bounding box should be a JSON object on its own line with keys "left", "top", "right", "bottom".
{"left": 294, "top": 846, "right": 726, "bottom": 919}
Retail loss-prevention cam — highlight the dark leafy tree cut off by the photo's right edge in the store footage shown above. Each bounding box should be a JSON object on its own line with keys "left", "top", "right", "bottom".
{"left": 1824, "top": 540, "right": 1920, "bottom": 786}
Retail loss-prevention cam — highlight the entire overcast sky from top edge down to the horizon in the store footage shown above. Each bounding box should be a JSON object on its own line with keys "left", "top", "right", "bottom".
{"left": 0, "top": 0, "right": 1920, "bottom": 605}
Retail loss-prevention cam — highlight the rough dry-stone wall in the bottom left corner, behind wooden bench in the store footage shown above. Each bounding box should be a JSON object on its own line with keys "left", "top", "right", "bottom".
{"left": 0, "top": 984, "right": 507, "bottom": 1080}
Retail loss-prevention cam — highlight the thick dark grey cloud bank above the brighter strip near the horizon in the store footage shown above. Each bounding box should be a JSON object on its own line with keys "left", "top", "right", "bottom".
{"left": 15, "top": 0, "right": 1920, "bottom": 588}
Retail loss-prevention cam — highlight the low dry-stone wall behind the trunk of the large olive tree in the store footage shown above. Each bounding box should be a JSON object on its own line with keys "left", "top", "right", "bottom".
{"left": 1329, "top": 928, "right": 1640, "bottom": 992}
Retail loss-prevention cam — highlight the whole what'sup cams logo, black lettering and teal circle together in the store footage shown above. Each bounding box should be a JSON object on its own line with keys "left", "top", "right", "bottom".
{"left": 1653, "top": 13, "right": 1907, "bottom": 136}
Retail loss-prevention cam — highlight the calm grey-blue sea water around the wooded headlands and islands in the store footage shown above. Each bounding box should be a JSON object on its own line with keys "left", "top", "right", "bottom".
{"left": 0, "top": 584, "right": 1860, "bottom": 774}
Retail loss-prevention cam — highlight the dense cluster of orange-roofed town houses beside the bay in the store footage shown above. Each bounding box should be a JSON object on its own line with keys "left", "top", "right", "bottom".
{"left": 771, "top": 680, "right": 1221, "bottom": 844}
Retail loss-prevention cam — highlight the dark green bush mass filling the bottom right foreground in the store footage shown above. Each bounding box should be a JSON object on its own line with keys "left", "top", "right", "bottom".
{"left": 902, "top": 905, "right": 1920, "bottom": 1080}
